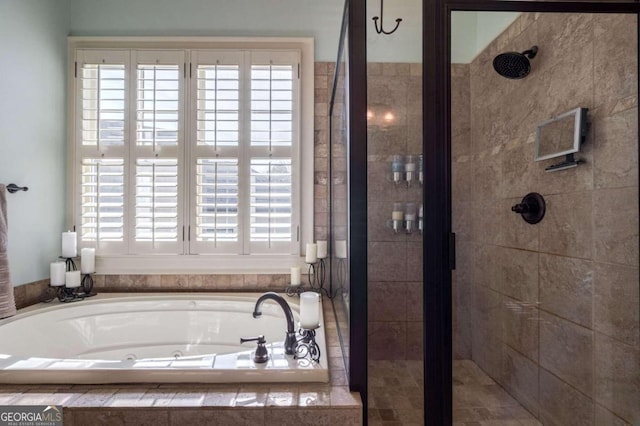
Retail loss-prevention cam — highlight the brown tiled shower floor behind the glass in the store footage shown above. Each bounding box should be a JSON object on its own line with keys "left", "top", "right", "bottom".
{"left": 368, "top": 360, "right": 541, "bottom": 426}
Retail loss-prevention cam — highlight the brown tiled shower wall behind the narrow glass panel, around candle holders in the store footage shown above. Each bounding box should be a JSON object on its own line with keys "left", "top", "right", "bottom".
{"left": 367, "top": 63, "right": 423, "bottom": 360}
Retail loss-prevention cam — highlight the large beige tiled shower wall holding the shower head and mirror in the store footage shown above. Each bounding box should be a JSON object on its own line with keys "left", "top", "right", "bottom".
{"left": 452, "top": 14, "right": 640, "bottom": 425}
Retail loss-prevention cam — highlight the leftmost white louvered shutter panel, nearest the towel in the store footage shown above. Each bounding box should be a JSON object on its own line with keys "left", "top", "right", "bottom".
{"left": 76, "top": 50, "right": 129, "bottom": 253}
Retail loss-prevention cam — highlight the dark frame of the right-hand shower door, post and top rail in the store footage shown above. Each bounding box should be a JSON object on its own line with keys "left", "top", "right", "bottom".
{"left": 420, "top": 0, "right": 640, "bottom": 426}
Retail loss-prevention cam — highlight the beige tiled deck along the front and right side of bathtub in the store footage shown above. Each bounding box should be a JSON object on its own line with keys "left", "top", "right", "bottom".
{"left": 0, "top": 294, "right": 362, "bottom": 426}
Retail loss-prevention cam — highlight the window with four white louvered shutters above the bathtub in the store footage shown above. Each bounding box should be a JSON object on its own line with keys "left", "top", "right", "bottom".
{"left": 73, "top": 39, "right": 313, "bottom": 270}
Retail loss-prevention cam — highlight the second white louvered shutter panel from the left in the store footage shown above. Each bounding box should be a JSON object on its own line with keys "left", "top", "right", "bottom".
{"left": 129, "top": 51, "right": 186, "bottom": 254}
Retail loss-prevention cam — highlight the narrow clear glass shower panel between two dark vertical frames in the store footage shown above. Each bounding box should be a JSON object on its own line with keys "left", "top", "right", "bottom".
{"left": 367, "top": 1, "right": 424, "bottom": 424}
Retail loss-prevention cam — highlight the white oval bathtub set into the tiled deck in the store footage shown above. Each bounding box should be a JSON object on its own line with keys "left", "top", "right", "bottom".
{"left": 0, "top": 293, "right": 329, "bottom": 384}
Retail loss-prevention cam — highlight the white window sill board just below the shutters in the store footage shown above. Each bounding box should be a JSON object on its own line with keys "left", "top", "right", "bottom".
{"left": 96, "top": 254, "right": 305, "bottom": 275}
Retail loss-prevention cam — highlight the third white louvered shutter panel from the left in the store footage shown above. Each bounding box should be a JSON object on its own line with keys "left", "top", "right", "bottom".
{"left": 190, "top": 50, "right": 244, "bottom": 254}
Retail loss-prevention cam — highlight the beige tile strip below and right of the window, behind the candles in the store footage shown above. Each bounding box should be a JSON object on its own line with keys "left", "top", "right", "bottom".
{"left": 14, "top": 62, "right": 335, "bottom": 308}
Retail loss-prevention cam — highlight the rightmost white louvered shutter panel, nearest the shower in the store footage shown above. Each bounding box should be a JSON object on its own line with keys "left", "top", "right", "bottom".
{"left": 245, "top": 51, "right": 299, "bottom": 253}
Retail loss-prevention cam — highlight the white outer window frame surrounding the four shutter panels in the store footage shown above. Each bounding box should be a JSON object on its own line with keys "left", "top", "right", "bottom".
{"left": 66, "top": 37, "right": 315, "bottom": 274}
